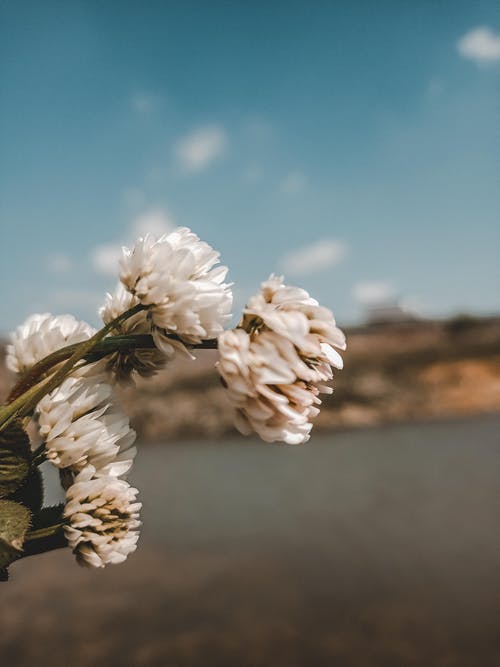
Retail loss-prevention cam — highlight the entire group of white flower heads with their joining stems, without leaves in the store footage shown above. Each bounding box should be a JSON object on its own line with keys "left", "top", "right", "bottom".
{"left": 0, "top": 227, "right": 345, "bottom": 567}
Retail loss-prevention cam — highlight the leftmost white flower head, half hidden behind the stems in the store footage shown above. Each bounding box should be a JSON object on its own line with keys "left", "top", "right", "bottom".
{"left": 7, "top": 313, "right": 95, "bottom": 374}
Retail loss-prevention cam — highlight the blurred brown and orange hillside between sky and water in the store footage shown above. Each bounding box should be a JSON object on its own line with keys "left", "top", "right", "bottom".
{"left": 0, "top": 317, "right": 500, "bottom": 441}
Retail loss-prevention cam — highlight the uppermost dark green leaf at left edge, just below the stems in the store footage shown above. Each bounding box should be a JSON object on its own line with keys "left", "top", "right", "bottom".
{"left": 0, "top": 420, "right": 31, "bottom": 498}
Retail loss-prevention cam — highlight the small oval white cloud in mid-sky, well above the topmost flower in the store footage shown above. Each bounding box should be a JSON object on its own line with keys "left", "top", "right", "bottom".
{"left": 174, "top": 126, "right": 228, "bottom": 173}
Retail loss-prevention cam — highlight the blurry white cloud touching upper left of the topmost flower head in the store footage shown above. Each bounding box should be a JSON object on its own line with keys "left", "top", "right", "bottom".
{"left": 90, "top": 208, "right": 175, "bottom": 276}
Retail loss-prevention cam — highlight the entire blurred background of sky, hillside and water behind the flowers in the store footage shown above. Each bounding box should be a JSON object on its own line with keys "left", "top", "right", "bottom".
{"left": 0, "top": 0, "right": 500, "bottom": 667}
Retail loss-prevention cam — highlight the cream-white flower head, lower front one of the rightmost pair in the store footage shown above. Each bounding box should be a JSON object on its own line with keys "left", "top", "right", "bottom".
{"left": 217, "top": 329, "right": 331, "bottom": 444}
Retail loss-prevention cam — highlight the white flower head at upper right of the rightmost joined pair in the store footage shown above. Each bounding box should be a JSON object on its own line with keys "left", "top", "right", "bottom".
{"left": 241, "top": 276, "right": 346, "bottom": 374}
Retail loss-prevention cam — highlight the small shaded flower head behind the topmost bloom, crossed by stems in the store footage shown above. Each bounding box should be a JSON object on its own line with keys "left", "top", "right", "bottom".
{"left": 99, "top": 283, "right": 172, "bottom": 383}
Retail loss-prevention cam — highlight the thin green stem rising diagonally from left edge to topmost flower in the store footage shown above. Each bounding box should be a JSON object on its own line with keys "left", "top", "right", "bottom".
{"left": 0, "top": 303, "right": 146, "bottom": 431}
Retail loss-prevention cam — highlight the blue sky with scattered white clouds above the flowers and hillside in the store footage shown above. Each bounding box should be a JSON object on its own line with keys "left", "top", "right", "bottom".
{"left": 0, "top": 0, "right": 500, "bottom": 332}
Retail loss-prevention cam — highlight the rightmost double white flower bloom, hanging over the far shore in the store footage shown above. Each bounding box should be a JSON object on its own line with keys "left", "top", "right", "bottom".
{"left": 218, "top": 276, "right": 345, "bottom": 444}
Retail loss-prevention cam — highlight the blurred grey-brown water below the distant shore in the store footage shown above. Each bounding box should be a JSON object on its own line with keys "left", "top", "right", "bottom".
{"left": 0, "top": 417, "right": 500, "bottom": 667}
